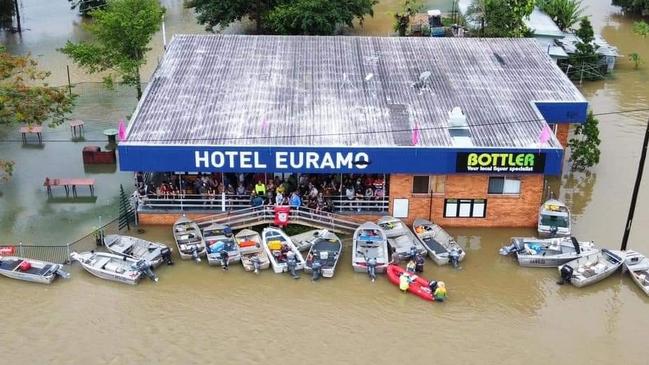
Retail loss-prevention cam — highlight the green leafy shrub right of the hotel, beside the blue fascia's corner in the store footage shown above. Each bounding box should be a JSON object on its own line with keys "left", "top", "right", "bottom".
{"left": 568, "top": 111, "right": 601, "bottom": 170}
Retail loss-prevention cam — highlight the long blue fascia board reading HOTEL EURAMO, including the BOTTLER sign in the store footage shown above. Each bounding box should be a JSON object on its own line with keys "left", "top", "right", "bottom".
{"left": 118, "top": 144, "right": 563, "bottom": 175}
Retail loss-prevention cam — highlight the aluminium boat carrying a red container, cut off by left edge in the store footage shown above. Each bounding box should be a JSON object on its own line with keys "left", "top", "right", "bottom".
{"left": 0, "top": 256, "right": 70, "bottom": 284}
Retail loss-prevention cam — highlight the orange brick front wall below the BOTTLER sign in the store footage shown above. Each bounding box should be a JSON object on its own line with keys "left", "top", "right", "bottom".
{"left": 390, "top": 174, "right": 543, "bottom": 227}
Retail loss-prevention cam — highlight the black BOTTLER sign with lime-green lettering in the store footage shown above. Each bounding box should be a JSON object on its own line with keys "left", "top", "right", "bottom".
{"left": 456, "top": 152, "right": 545, "bottom": 174}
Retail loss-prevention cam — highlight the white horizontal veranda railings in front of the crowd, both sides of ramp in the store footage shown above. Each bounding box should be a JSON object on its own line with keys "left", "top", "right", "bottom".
{"left": 138, "top": 193, "right": 389, "bottom": 212}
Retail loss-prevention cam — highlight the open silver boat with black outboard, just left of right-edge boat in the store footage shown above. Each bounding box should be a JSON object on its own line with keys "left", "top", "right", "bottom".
{"left": 559, "top": 249, "right": 626, "bottom": 288}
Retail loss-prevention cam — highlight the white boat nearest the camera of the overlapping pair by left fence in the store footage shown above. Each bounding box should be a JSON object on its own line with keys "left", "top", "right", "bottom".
{"left": 70, "top": 251, "right": 158, "bottom": 285}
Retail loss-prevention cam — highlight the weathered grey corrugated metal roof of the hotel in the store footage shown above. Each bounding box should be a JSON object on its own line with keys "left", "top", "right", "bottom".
{"left": 126, "top": 35, "right": 584, "bottom": 148}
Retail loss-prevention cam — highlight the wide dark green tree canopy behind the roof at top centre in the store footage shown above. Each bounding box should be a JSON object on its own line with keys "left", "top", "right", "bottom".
{"left": 186, "top": 0, "right": 378, "bottom": 35}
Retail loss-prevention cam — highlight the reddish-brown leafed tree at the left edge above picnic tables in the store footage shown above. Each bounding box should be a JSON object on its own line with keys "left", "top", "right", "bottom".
{"left": 0, "top": 47, "right": 74, "bottom": 179}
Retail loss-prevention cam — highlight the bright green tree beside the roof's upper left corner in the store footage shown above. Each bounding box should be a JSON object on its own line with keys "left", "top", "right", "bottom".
{"left": 60, "top": 0, "right": 164, "bottom": 99}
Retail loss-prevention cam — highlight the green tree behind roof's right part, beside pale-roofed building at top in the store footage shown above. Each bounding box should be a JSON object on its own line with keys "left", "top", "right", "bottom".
{"left": 467, "top": 0, "right": 535, "bottom": 38}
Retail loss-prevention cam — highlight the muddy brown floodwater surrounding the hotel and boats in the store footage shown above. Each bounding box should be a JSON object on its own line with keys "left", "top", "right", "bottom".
{"left": 0, "top": 0, "right": 649, "bottom": 364}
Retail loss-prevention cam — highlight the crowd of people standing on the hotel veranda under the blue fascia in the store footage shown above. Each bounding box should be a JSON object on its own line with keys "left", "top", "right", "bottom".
{"left": 135, "top": 172, "right": 387, "bottom": 211}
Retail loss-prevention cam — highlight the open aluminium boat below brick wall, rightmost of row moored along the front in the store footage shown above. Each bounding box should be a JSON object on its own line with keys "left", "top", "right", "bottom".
{"left": 412, "top": 218, "right": 466, "bottom": 266}
